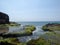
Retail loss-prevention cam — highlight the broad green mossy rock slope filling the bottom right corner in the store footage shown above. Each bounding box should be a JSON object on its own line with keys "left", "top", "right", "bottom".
{"left": 27, "top": 32, "right": 60, "bottom": 45}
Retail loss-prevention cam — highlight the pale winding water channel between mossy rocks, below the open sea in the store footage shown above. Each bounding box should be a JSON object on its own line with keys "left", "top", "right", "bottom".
{"left": 18, "top": 26, "right": 45, "bottom": 42}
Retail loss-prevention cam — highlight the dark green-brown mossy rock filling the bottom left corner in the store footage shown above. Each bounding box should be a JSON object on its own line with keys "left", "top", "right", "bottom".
{"left": 0, "top": 37, "right": 26, "bottom": 45}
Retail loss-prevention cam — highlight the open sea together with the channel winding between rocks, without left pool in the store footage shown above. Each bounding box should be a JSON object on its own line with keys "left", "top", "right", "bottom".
{"left": 18, "top": 21, "right": 60, "bottom": 42}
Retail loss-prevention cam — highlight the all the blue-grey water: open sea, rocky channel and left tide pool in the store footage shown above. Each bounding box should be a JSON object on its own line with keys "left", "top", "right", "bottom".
{"left": 0, "top": 21, "right": 60, "bottom": 42}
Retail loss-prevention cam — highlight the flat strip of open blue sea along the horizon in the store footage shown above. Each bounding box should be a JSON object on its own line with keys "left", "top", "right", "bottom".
{"left": 18, "top": 21, "right": 60, "bottom": 26}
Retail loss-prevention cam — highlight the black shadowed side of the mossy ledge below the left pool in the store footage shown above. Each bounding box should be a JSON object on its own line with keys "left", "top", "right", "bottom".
{"left": 0, "top": 33, "right": 32, "bottom": 38}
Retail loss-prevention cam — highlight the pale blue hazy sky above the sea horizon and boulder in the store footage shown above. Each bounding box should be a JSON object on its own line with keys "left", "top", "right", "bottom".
{"left": 0, "top": 0, "right": 60, "bottom": 21}
